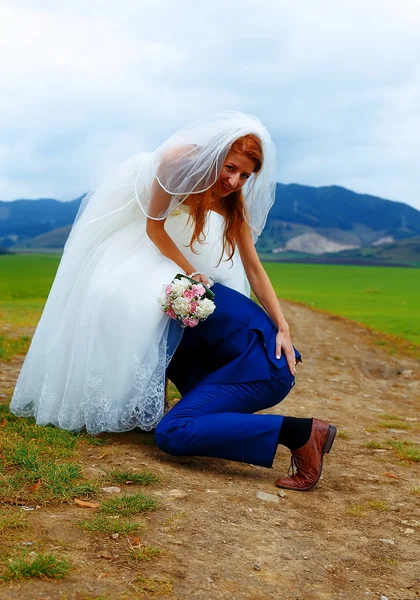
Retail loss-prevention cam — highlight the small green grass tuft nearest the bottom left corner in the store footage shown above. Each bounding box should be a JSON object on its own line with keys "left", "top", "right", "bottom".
{"left": 1, "top": 553, "right": 72, "bottom": 581}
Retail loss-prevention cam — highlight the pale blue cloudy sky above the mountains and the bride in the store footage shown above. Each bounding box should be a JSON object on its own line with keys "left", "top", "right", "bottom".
{"left": 0, "top": 0, "right": 420, "bottom": 209}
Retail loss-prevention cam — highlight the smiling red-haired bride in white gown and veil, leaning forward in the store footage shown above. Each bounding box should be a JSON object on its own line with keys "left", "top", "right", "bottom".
{"left": 11, "top": 111, "right": 294, "bottom": 433}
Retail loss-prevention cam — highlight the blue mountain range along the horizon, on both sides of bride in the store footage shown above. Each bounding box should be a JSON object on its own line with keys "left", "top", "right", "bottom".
{"left": 0, "top": 183, "right": 420, "bottom": 262}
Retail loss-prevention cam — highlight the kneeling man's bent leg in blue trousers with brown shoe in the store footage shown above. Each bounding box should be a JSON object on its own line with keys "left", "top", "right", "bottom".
{"left": 155, "top": 366, "right": 337, "bottom": 491}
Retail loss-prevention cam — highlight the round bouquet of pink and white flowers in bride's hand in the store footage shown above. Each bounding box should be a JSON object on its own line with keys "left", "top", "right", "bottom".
{"left": 158, "top": 275, "right": 216, "bottom": 327}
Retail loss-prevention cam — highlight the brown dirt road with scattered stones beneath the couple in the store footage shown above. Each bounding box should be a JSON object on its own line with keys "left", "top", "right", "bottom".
{"left": 0, "top": 302, "right": 420, "bottom": 600}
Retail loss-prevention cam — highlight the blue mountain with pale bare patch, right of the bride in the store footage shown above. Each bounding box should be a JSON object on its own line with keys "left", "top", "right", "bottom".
{"left": 258, "top": 183, "right": 420, "bottom": 253}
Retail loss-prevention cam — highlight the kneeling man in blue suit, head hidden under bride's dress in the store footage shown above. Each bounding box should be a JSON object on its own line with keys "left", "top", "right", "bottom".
{"left": 155, "top": 284, "right": 337, "bottom": 491}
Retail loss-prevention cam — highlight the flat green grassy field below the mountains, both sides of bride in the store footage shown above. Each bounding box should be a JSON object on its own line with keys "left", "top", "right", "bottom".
{"left": 0, "top": 255, "right": 420, "bottom": 358}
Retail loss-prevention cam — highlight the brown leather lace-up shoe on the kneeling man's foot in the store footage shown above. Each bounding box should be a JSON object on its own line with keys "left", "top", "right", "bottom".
{"left": 276, "top": 419, "right": 337, "bottom": 492}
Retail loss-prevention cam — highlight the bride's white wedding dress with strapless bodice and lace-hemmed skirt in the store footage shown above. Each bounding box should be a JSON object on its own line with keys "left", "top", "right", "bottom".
{"left": 11, "top": 205, "right": 249, "bottom": 433}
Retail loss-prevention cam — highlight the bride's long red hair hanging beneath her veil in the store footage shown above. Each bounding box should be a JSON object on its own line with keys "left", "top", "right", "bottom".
{"left": 189, "top": 134, "right": 264, "bottom": 263}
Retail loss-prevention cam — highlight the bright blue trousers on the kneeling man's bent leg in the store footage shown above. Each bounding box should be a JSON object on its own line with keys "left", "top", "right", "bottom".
{"left": 155, "top": 364, "right": 295, "bottom": 467}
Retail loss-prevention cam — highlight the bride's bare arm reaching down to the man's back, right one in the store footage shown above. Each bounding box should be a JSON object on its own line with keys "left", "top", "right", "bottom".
{"left": 238, "top": 222, "right": 296, "bottom": 374}
